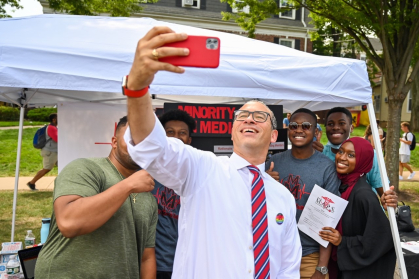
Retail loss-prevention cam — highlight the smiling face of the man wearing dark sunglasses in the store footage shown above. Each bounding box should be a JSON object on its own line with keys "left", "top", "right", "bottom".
{"left": 288, "top": 112, "right": 316, "bottom": 148}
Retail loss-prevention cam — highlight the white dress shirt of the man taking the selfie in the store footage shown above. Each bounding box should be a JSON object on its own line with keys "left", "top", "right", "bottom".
{"left": 124, "top": 115, "right": 301, "bottom": 279}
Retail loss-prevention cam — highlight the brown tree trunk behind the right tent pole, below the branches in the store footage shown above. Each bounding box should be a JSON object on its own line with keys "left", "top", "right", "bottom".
{"left": 385, "top": 98, "right": 404, "bottom": 192}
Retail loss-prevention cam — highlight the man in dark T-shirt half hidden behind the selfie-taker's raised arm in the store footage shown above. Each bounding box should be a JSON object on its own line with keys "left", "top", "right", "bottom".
{"left": 151, "top": 109, "right": 196, "bottom": 279}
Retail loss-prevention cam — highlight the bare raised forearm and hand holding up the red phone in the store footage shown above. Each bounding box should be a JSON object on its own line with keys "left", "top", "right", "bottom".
{"left": 126, "top": 27, "right": 189, "bottom": 145}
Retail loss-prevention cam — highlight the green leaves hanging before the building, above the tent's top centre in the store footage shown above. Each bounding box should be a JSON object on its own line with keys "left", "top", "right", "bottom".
{"left": 220, "top": 0, "right": 291, "bottom": 38}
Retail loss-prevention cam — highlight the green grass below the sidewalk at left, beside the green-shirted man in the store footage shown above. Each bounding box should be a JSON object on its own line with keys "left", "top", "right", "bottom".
{"left": 0, "top": 191, "right": 52, "bottom": 243}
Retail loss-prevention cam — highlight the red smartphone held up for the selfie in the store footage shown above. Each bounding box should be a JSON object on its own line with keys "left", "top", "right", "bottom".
{"left": 159, "top": 36, "right": 220, "bottom": 68}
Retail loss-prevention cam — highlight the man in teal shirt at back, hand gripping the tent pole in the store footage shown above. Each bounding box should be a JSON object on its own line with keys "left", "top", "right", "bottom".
{"left": 313, "top": 107, "right": 397, "bottom": 209}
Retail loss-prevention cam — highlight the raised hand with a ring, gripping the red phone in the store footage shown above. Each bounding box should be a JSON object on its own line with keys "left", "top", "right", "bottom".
{"left": 127, "top": 26, "right": 189, "bottom": 90}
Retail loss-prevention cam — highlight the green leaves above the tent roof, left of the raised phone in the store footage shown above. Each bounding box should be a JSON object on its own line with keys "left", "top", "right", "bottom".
{"left": 48, "top": 0, "right": 157, "bottom": 17}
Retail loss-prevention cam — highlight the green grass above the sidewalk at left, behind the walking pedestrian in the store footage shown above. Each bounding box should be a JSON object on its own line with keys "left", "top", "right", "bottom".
{"left": 0, "top": 128, "right": 57, "bottom": 177}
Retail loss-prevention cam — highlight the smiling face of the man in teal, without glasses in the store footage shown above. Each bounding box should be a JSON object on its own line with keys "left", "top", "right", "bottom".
{"left": 326, "top": 112, "right": 353, "bottom": 145}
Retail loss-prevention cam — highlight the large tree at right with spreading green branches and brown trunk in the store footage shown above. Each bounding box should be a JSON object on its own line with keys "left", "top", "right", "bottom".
{"left": 228, "top": 0, "right": 419, "bottom": 191}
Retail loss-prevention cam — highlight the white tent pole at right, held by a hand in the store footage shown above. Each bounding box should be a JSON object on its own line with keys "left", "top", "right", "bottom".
{"left": 368, "top": 103, "right": 407, "bottom": 279}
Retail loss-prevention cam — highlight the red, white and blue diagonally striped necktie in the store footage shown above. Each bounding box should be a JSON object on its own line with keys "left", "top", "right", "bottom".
{"left": 247, "top": 165, "right": 270, "bottom": 279}
